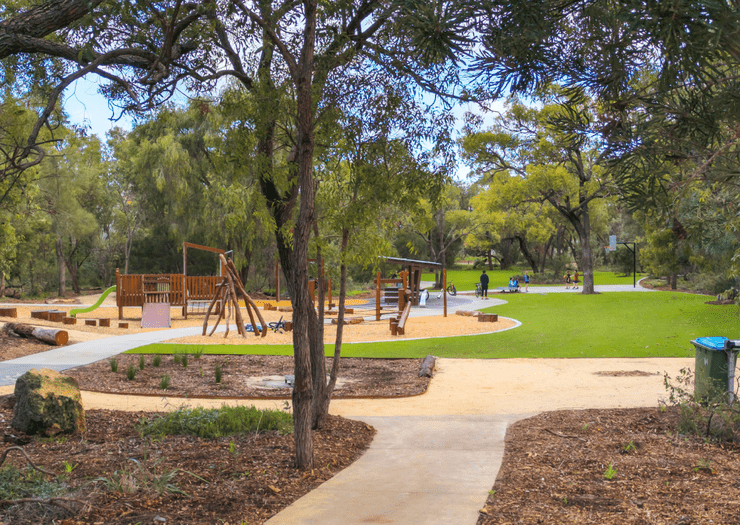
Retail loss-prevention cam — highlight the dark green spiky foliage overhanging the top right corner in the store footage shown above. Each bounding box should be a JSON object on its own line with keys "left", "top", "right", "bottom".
{"left": 474, "top": 0, "right": 740, "bottom": 213}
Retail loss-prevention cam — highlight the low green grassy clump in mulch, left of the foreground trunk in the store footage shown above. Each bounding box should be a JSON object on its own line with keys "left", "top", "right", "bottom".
{"left": 137, "top": 406, "right": 293, "bottom": 438}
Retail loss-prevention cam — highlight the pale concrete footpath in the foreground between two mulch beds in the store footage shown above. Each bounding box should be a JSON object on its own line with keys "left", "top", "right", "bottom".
{"left": 267, "top": 416, "right": 517, "bottom": 525}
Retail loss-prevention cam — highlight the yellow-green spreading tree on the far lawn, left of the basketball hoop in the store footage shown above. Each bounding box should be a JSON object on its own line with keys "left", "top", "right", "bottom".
{"left": 462, "top": 90, "right": 610, "bottom": 294}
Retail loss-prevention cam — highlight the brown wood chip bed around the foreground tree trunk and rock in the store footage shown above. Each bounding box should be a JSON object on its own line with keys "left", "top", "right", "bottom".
{"left": 0, "top": 409, "right": 375, "bottom": 525}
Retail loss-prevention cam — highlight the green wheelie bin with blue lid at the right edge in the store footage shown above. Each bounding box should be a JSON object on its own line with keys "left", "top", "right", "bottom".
{"left": 691, "top": 337, "right": 738, "bottom": 398}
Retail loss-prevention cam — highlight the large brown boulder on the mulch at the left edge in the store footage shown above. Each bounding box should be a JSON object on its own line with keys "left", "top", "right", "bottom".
{"left": 12, "top": 368, "right": 86, "bottom": 436}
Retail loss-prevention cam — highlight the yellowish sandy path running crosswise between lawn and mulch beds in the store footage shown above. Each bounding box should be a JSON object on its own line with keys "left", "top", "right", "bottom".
{"left": 0, "top": 358, "right": 694, "bottom": 416}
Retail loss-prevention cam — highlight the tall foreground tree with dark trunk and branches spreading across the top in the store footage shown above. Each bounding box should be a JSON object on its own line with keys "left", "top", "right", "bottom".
{"left": 0, "top": 0, "right": 471, "bottom": 468}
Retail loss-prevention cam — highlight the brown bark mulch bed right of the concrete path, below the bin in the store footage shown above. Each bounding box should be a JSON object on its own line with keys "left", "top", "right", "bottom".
{"left": 478, "top": 408, "right": 740, "bottom": 525}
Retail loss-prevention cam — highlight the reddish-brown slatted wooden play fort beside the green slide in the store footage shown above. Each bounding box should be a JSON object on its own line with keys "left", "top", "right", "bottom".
{"left": 116, "top": 242, "right": 226, "bottom": 320}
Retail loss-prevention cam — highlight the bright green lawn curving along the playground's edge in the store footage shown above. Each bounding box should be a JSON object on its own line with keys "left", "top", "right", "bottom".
{"left": 129, "top": 292, "right": 740, "bottom": 358}
